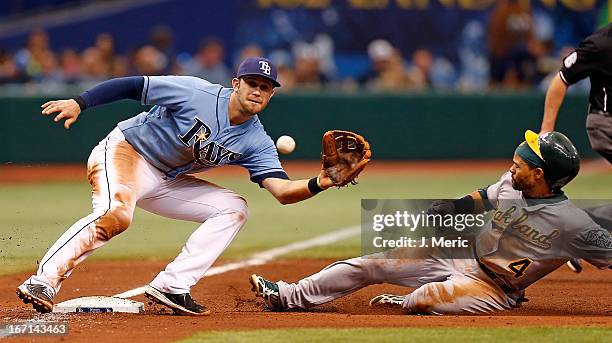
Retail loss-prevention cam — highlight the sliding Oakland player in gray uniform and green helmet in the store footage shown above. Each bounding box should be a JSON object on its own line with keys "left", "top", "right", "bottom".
{"left": 250, "top": 131, "right": 612, "bottom": 314}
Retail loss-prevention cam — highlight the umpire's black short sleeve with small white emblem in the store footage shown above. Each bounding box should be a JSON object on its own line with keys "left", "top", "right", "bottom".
{"left": 559, "top": 38, "right": 599, "bottom": 85}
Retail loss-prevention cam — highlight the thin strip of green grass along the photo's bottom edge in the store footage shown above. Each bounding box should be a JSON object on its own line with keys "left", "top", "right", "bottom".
{"left": 180, "top": 327, "right": 612, "bottom": 343}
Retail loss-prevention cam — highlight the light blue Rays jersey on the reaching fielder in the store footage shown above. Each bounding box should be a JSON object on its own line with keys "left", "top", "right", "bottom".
{"left": 118, "top": 76, "right": 287, "bottom": 183}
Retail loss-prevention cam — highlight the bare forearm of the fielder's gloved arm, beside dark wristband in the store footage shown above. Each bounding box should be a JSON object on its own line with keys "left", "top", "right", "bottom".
{"left": 262, "top": 174, "right": 332, "bottom": 205}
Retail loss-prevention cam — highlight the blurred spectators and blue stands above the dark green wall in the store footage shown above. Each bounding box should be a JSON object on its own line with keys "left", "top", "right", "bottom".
{"left": 0, "top": 0, "right": 608, "bottom": 93}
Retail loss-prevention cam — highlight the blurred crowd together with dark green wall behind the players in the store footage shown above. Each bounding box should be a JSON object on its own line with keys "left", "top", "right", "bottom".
{"left": 0, "top": 0, "right": 608, "bottom": 163}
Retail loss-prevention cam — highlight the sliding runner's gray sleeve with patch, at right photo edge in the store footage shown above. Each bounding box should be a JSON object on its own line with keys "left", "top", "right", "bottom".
{"left": 567, "top": 221, "right": 612, "bottom": 268}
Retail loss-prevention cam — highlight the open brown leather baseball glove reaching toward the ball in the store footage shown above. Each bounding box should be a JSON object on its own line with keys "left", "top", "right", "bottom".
{"left": 321, "top": 130, "right": 372, "bottom": 187}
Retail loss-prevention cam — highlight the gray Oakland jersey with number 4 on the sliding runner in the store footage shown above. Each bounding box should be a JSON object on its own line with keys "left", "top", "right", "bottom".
{"left": 476, "top": 172, "right": 612, "bottom": 289}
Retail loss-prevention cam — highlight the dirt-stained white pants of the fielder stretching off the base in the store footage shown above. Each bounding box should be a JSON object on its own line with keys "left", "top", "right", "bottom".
{"left": 27, "top": 128, "right": 248, "bottom": 294}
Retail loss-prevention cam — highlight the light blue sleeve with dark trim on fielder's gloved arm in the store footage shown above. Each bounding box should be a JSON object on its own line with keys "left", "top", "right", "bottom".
{"left": 237, "top": 138, "right": 289, "bottom": 187}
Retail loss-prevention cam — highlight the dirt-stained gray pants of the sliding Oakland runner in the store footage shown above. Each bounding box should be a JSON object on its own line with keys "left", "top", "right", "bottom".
{"left": 278, "top": 249, "right": 516, "bottom": 314}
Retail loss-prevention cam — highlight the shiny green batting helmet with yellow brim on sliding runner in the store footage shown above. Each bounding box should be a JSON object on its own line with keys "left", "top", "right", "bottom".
{"left": 525, "top": 130, "right": 580, "bottom": 189}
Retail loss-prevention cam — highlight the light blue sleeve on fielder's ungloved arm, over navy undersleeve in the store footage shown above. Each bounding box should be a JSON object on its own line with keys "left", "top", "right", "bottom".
{"left": 141, "top": 76, "right": 200, "bottom": 109}
